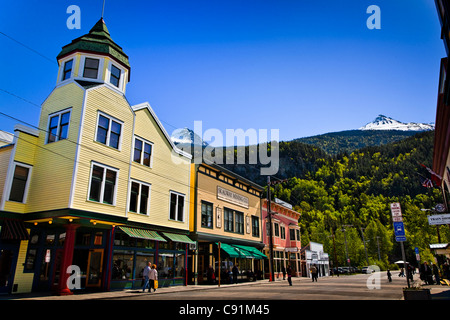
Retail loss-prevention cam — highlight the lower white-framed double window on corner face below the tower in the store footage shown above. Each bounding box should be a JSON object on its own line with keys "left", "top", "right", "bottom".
{"left": 89, "top": 163, "right": 119, "bottom": 205}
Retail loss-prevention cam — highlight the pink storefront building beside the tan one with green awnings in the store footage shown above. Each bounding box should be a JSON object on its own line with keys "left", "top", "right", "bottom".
{"left": 262, "top": 199, "right": 301, "bottom": 280}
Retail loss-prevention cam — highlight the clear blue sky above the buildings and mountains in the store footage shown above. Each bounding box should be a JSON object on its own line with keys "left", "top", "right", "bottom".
{"left": 0, "top": 0, "right": 445, "bottom": 145}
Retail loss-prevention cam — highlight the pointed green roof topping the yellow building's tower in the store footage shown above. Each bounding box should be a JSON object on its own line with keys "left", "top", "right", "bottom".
{"left": 56, "top": 18, "right": 130, "bottom": 69}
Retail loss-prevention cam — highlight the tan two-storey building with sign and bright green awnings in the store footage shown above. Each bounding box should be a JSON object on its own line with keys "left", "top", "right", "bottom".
{"left": 189, "top": 163, "right": 266, "bottom": 284}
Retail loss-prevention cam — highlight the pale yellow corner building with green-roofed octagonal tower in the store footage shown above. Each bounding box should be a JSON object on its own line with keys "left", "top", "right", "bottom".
{"left": 0, "top": 19, "right": 192, "bottom": 294}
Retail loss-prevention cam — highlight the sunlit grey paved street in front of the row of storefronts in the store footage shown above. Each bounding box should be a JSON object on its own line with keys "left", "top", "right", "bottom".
{"left": 105, "top": 272, "right": 418, "bottom": 300}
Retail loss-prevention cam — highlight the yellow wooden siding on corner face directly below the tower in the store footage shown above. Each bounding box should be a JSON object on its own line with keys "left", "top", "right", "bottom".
{"left": 72, "top": 86, "right": 134, "bottom": 216}
